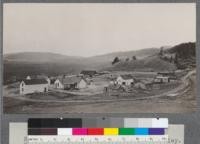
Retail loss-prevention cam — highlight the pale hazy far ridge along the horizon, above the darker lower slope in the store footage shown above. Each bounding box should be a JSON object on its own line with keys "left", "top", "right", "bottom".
{"left": 4, "top": 48, "right": 159, "bottom": 63}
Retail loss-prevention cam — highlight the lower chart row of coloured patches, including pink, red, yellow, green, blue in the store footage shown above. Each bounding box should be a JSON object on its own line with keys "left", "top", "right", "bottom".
{"left": 28, "top": 128, "right": 165, "bottom": 136}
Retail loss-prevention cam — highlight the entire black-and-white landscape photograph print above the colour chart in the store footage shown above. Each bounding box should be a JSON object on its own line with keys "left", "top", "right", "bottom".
{"left": 3, "top": 3, "right": 197, "bottom": 114}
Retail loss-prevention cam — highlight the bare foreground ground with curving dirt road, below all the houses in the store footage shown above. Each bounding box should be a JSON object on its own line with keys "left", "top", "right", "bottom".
{"left": 4, "top": 75, "right": 197, "bottom": 114}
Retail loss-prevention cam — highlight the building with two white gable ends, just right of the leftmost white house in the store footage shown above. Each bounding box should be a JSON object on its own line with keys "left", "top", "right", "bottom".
{"left": 54, "top": 76, "right": 88, "bottom": 89}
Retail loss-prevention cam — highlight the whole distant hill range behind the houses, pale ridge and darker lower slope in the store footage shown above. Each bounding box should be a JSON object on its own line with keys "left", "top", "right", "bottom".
{"left": 4, "top": 48, "right": 159, "bottom": 82}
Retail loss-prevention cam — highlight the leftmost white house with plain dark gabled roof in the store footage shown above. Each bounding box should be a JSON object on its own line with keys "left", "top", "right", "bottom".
{"left": 20, "top": 79, "right": 48, "bottom": 94}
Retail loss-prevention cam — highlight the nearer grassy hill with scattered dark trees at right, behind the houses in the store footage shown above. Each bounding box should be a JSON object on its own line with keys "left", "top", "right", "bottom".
{"left": 107, "top": 42, "right": 196, "bottom": 71}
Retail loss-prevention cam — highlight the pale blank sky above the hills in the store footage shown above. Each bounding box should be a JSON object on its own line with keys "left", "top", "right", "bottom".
{"left": 3, "top": 3, "right": 196, "bottom": 57}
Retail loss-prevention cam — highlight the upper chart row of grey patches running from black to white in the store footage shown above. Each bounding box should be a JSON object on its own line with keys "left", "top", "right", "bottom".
{"left": 28, "top": 118, "right": 168, "bottom": 128}
